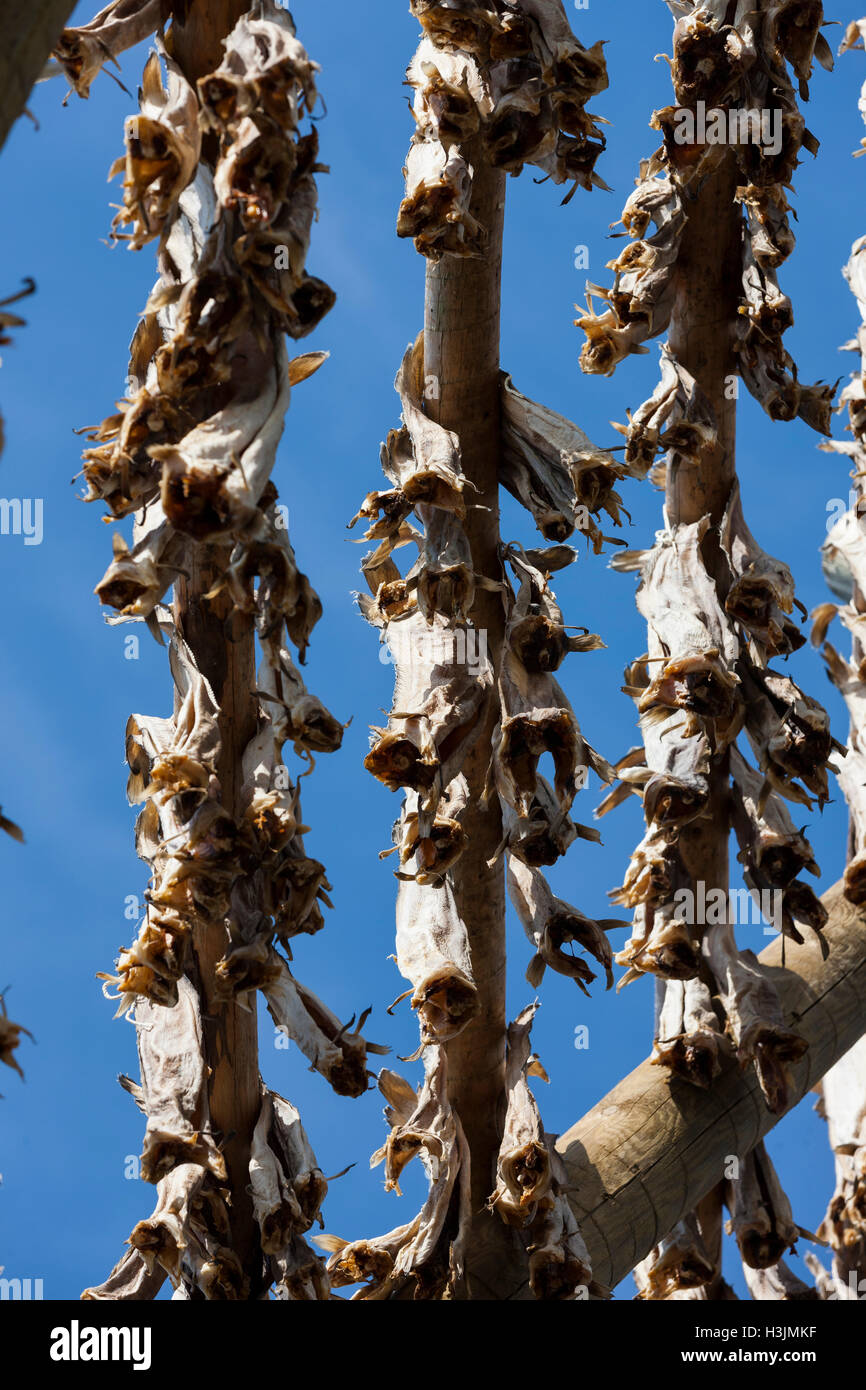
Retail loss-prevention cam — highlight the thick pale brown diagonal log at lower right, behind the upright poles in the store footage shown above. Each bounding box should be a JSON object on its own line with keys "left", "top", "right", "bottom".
{"left": 557, "top": 883, "right": 866, "bottom": 1289}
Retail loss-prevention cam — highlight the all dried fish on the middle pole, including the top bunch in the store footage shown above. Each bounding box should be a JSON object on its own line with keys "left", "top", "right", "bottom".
{"left": 318, "top": 0, "right": 626, "bottom": 1300}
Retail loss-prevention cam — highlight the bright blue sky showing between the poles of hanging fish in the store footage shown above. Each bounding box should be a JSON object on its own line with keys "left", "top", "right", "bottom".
{"left": 0, "top": 0, "right": 866, "bottom": 1298}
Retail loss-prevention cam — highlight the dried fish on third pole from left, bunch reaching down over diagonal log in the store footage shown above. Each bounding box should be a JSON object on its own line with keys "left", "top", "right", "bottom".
{"left": 599, "top": 505, "right": 834, "bottom": 1112}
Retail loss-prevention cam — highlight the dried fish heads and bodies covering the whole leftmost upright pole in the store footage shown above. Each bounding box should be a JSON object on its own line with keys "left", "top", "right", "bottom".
{"left": 77, "top": 0, "right": 386, "bottom": 1300}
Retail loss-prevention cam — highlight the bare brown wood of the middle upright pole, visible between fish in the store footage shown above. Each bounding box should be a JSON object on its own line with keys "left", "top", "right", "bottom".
{"left": 424, "top": 146, "right": 525, "bottom": 1298}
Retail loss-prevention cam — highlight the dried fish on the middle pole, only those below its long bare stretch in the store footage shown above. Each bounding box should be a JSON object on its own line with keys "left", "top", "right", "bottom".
{"left": 328, "top": 350, "right": 621, "bottom": 1298}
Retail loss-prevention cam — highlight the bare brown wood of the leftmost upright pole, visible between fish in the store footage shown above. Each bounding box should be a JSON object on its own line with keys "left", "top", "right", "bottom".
{"left": 172, "top": 0, "right": 261, "bottom": 1269}
